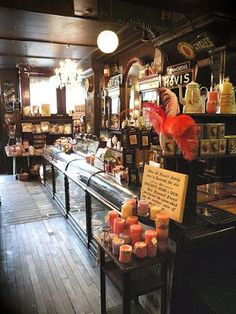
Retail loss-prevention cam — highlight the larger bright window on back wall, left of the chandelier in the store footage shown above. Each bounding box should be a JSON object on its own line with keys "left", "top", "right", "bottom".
{"left": 29, "top": 76, "right": 57, "bottom": 114}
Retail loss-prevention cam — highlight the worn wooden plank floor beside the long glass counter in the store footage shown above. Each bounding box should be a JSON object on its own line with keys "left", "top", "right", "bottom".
{"left": 0, "top": 176, "right": 121, "bottom": 314}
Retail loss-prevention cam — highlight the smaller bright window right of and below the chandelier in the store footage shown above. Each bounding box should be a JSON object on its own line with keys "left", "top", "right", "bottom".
{"left": 66, "top": 83, "right": 86, "bottom": 114}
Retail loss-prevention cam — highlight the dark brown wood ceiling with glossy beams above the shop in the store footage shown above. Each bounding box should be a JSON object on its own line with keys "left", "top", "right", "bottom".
{"left": 0, "top": 0, "right": 233, "bottom": 68}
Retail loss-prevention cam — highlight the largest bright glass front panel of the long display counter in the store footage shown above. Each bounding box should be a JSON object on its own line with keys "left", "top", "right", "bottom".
{"left": 69, "top": 179, "right": 86, "bottom": 232}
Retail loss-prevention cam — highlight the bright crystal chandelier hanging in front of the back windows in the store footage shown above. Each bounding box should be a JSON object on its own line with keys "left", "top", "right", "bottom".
{"left": 54, "top": 59, "right": 82, "bottom": 88}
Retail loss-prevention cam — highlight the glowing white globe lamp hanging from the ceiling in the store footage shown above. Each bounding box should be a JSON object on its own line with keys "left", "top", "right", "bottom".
{"left": 97, "top": 30, "right": 119, "bottom": 53}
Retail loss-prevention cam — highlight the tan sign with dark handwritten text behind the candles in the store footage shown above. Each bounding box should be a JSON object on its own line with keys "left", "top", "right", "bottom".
{"left": 141, "top": 165, "right": 188, "bottom": 223}
